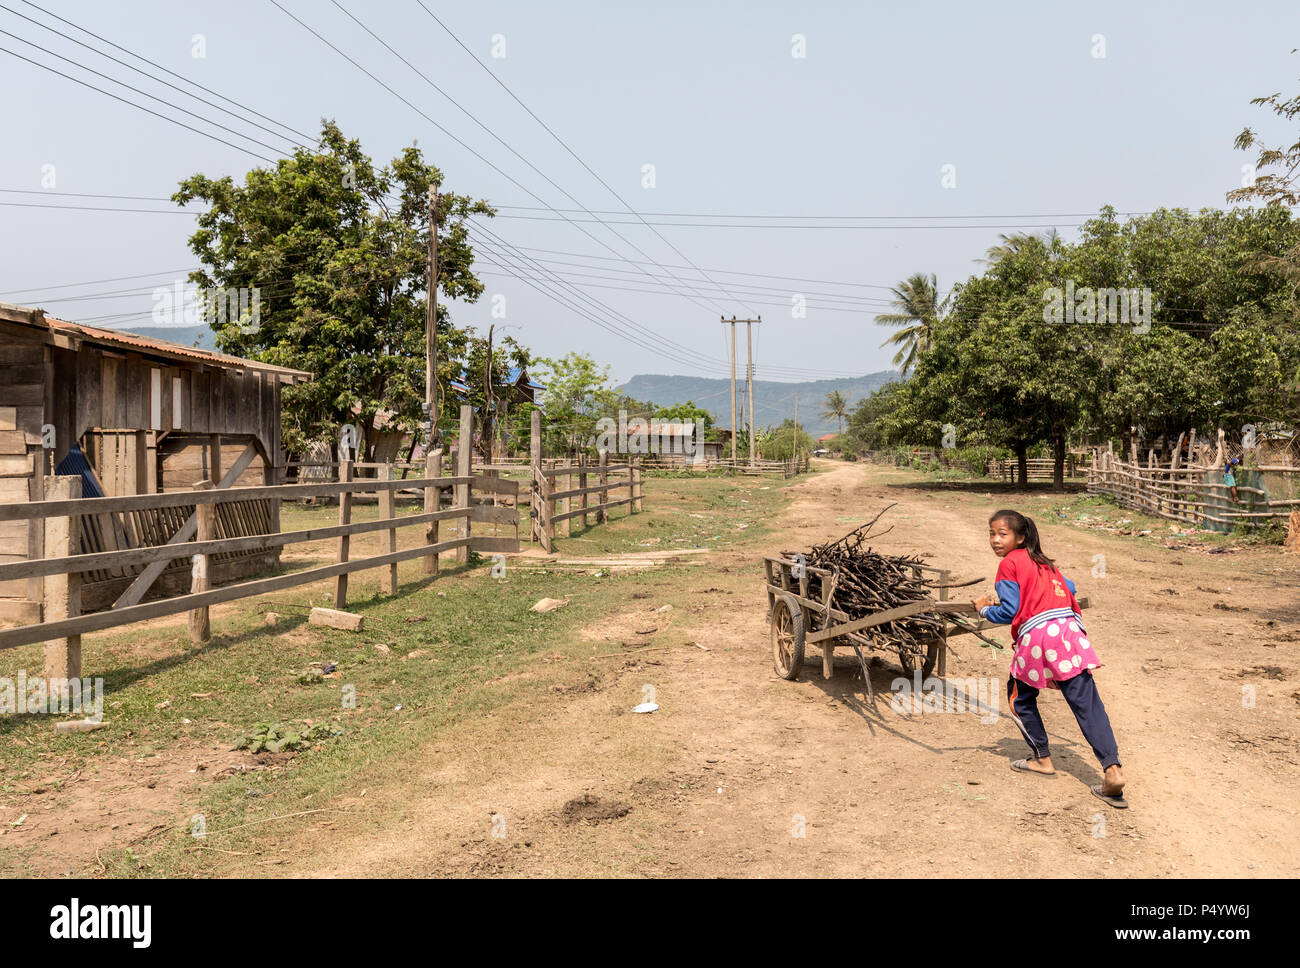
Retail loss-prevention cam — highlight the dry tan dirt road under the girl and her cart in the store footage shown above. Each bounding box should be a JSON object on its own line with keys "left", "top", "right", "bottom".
{"left": 266, "top": 465, "right": 1300, "bottom": 877}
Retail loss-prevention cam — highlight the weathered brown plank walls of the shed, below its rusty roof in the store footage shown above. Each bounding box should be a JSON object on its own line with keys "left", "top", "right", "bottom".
{"left": 0, "top": 321, "right": 283, "bottom": 625}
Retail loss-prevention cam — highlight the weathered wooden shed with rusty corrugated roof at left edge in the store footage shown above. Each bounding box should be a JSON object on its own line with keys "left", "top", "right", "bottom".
{"left": 0, "top": 303, "right": 311, "bottom": 625}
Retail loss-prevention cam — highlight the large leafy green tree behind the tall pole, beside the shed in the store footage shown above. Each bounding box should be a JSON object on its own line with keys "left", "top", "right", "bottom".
{"left": 172, "top": 121, "right": 493, "bottom": 460}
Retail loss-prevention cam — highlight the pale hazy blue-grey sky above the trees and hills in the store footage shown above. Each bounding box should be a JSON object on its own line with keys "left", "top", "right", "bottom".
{"left": 0, "top": 0, "right": 1300, "bottom": 379}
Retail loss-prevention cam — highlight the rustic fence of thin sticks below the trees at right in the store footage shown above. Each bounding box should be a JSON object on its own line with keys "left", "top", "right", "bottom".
{"left": 1088, "top": 451, "right": 1300, "bottom": 531}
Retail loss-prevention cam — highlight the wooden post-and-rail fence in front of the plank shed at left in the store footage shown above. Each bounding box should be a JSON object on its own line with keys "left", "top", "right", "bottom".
{"left": 0, "top": 407, "right": 519, "bottom": 678}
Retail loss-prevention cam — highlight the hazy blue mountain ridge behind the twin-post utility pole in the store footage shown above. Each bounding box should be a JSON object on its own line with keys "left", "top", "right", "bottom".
{"left": 619, "top": 370, "right": 898, "bottom": 437}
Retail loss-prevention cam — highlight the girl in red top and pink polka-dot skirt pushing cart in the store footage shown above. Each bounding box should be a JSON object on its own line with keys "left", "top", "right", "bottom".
{"left": 974, "top": 511, "right": 1128, "bottom": 809}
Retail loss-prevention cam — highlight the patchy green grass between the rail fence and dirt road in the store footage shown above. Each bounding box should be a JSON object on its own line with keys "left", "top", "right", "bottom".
{"left": 0, "top": 465, "right": 800, "bottom": 877}
